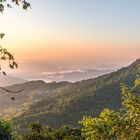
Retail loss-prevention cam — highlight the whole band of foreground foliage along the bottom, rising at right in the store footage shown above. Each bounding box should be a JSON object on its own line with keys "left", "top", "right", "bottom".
{"left": 0, "top": 62, "right": 140, "bottom": 140}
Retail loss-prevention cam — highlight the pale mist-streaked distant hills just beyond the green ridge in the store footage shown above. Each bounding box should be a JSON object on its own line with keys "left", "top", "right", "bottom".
{"left": 39, "top": 68, "right": 113, "bottom": 82}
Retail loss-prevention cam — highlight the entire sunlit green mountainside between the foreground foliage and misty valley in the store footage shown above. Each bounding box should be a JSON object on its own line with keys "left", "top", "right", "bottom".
{"left": 0, "top": 59, "right": 140, "bottom": 129}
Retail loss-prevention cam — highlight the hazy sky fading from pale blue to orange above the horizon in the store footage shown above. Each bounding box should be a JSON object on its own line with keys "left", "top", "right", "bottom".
{"left": 0, "top": 0, "right": 140, "bottom": 76}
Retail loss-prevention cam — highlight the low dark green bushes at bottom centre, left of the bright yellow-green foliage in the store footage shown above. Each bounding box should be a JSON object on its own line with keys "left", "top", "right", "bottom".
{"left": 23, "top": 123, "right": 83, "bottom": 140}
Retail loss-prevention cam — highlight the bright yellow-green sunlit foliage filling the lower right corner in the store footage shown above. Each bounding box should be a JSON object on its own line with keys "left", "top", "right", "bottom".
{"left": 80, "top": 66, "right": 140, "bottom": 140}
